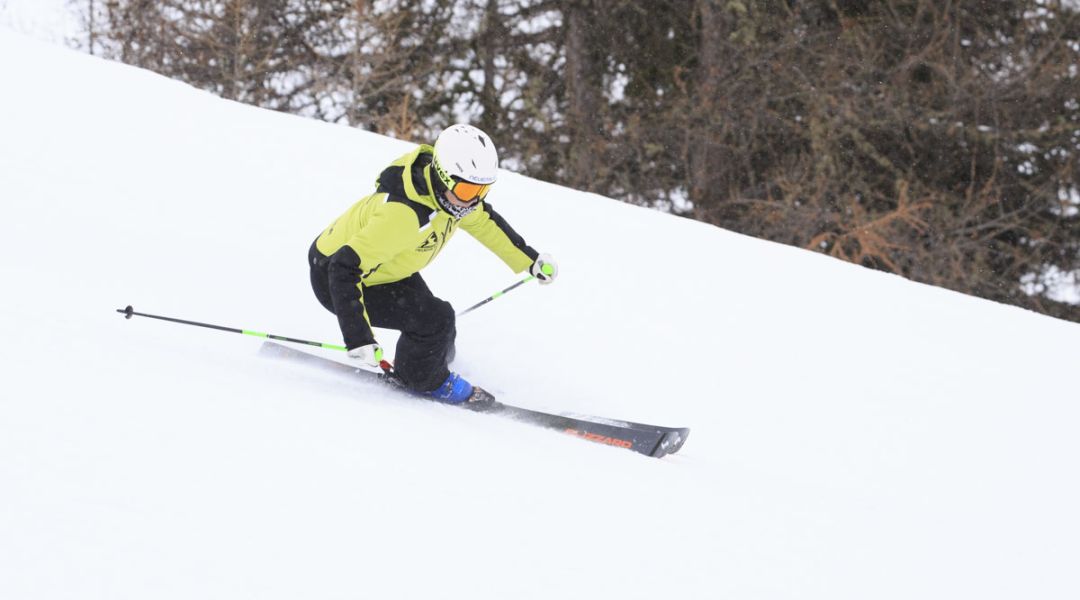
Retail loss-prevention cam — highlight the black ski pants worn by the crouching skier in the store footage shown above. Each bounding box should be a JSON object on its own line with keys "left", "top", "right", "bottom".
{"left": 308, "top": 244, "right": 457, "bottom": 392}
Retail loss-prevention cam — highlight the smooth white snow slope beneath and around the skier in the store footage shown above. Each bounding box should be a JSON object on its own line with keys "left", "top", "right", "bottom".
{"left": 0, "top": 31, "right": 1080, "bottom": 600}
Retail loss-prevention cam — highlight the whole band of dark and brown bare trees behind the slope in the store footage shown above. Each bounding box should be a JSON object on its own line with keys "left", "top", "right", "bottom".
{"left": 71, "top": 0, "right": 1080, "bottom": 321}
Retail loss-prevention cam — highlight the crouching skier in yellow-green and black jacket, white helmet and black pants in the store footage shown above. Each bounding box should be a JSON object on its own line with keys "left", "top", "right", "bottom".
{"left": 308, "top": 124, "right": 558, "bottom": 404}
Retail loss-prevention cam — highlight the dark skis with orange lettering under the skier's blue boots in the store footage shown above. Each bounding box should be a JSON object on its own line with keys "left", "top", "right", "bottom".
{"left": 259, "top": 341, "right": 690, "bottom": 458}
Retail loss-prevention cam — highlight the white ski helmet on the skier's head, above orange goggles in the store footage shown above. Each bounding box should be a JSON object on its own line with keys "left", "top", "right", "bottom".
{"left": 432, "top": 123, "right": 499, "bottom": 190}
